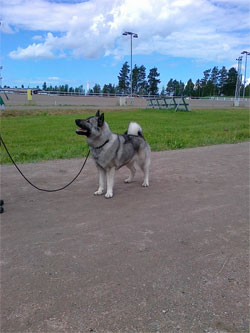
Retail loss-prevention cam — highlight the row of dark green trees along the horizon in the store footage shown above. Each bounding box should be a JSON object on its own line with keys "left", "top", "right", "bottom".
{"left": 38, "top": 61, "right": 250, "bottom": 97}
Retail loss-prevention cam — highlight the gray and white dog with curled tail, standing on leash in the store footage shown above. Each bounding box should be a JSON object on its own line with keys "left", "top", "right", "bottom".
{"left": 75, "top": 111, "right": 150, "bottom": 198}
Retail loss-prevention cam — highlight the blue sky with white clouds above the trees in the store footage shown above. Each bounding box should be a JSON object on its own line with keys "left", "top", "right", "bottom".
{"left": 0, "top": 0, "right": 250, "bottom": 89}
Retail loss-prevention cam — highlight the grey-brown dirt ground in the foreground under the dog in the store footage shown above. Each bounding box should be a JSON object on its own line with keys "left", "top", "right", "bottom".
{"left": 1, "top": 143, "right": 249, "bottom": 333}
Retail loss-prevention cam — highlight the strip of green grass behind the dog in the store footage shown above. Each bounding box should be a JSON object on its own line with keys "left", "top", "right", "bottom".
{"left": 1, "top": 109, "right": 250, "bottom": 164}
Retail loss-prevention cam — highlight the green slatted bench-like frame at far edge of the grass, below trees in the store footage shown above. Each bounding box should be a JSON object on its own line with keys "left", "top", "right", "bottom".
{"left": 147, "top": 96, "right": 190, "bottom": 112}
